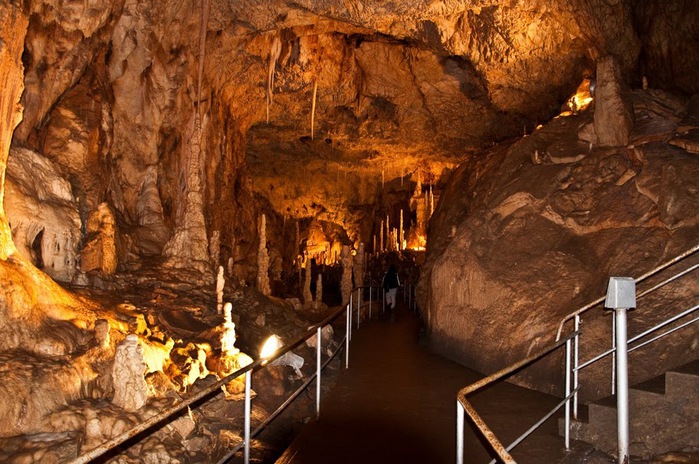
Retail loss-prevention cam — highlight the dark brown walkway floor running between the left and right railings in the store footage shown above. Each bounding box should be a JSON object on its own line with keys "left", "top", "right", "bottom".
{"left": 277, "top": 309, "right": 566, "bottom": 464}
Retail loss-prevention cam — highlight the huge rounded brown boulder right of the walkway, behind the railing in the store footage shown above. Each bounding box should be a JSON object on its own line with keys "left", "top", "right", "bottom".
{"left": 420, "top": 91, "right": 699, "bottom": 397}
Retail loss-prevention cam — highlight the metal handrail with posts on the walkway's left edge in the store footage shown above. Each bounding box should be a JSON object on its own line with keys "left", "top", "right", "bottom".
{"left": 67, "top": 282, "right": 380, "bottom": 464}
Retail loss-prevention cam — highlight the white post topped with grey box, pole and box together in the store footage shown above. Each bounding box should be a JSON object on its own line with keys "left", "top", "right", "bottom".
{"left": 604, "top": 277, "right": 636, "bottom": 464}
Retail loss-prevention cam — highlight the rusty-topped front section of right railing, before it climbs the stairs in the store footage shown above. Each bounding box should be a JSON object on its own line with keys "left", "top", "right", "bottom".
{"left": 456, "top": 332, "right": 578, "bottom": 464}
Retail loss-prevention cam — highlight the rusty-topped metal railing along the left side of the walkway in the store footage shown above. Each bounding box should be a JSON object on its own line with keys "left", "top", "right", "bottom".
{"left": 68, "top": 286, "right": 376, "bottom": 464}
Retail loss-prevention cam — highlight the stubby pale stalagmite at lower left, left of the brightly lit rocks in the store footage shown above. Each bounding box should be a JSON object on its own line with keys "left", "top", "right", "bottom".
{"left": 112, "top": 334, "right": 148, "bottom": 411}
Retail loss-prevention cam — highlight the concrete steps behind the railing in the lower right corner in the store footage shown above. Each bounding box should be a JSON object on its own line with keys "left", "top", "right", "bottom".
{"left": 559, "top": 360, "right": 699, "bottom": 459}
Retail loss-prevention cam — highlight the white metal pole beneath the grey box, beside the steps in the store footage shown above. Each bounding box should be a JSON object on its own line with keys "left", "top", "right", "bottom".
{"left": 614, "top": 308, "right": 629, "bottom": 464}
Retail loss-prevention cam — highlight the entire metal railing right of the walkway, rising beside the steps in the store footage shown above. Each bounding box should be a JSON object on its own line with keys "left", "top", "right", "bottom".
{"left": 456, "top": 245, "right": 699, "bottom": 464}
